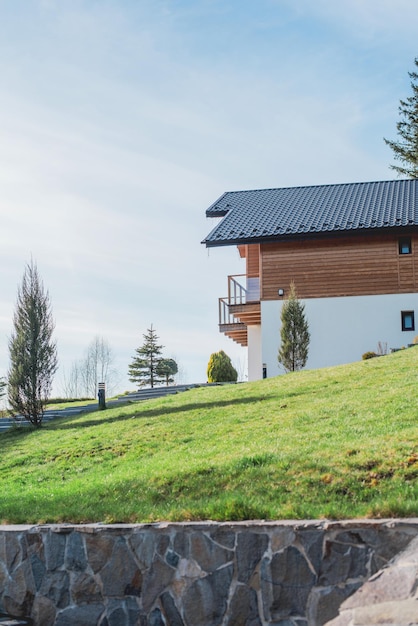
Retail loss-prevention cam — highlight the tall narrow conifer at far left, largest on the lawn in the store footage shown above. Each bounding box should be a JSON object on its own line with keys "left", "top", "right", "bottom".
{"left": 7, "top": 261, "right": 58, "bottom": 428}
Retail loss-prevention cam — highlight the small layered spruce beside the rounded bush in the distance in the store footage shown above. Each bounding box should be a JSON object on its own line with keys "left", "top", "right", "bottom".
{"left": 129, "top": 324, "right": 164, "bottom": 387}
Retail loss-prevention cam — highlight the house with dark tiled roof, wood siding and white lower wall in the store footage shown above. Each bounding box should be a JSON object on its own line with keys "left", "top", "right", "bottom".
{"left": 202, "top": 180, "right": 418, "bottom": 380}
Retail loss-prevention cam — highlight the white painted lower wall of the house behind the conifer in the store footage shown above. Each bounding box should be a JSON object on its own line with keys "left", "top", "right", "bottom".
{"left": 259, "top": 293, "right": 418, "bottom": 378}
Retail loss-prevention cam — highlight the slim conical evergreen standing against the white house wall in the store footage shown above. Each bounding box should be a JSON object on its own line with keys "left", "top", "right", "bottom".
{"left": 278, "top": 283, "right": 310, "bottom": 372}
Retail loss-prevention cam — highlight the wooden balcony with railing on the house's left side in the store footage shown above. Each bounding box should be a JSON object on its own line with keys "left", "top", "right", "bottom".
{"left": 219, "top": 274, "right": 261, "bottom": 346}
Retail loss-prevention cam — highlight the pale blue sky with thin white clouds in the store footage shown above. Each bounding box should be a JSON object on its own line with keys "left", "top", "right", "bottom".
{"left": 0, "top": 0, "right": 418, "bottom": 395}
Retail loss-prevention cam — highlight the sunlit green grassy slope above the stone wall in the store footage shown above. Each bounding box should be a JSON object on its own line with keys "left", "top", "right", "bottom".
{"left": 0, "top": 348, "right": 418, "bottom": 523}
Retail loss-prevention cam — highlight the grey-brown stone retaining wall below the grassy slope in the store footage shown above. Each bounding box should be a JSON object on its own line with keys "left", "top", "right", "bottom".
{"left": 0, "top": 519, "right": 418, "bottom": 626}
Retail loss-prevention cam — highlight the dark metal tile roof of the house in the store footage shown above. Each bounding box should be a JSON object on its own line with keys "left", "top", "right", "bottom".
{"left": 202, "top": 179, "right": 418, "bottom": 246}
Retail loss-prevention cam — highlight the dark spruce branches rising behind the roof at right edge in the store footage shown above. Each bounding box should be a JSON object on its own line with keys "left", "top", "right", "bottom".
{"left": 385, "top": 58, "right": 418, "bottom": 178}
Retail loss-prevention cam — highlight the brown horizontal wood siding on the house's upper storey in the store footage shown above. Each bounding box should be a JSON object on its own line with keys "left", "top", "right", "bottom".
{"left": 260, "top": 235, "right": 418, "bottom": 300}
